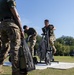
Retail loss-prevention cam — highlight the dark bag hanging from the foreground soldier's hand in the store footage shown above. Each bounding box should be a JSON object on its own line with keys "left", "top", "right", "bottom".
{"left": 19, "top": 38, "right": 35, "bottom": 73}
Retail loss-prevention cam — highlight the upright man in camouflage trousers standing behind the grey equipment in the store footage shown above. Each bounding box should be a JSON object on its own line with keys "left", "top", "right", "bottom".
{"left": 42, "top": 19, "right": 56, "bottom": 53}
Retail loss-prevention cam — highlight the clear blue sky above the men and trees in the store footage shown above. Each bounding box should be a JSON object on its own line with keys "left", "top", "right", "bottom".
{"left": 16, "top": 0, "right": 74, "bottom": 38}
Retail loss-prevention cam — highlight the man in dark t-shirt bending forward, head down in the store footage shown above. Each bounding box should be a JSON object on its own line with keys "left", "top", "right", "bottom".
{"left": 23, "top": 25, "right": 37, "bottom": 56}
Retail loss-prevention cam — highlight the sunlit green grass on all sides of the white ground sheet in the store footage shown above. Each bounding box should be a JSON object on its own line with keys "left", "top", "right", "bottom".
{"left": 0, "top": 56, "right": 74, "bottom": 75}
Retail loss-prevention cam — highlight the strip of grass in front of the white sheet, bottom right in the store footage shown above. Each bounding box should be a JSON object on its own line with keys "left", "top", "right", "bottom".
{"left": 29, "top": 69, "right": 74, "bottom": 75}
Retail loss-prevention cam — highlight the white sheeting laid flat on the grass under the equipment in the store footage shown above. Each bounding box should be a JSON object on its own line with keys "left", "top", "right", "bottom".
{"left": 4, "top": 62, "right": 74, "bottom": 70}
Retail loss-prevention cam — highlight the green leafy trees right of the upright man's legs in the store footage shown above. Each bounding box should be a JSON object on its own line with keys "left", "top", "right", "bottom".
{"left": 55, "top": 36, "right": 74, "bottom": 55}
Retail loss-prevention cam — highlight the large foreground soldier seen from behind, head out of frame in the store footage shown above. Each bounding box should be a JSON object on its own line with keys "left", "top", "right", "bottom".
{"left": 0, "top": 0, "right": 26, "bottom": 75}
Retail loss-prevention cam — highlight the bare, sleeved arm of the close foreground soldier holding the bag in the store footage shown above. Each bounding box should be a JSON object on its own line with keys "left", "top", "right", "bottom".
{"left": 7, "top": 0, "right": 24, "bottom": 37}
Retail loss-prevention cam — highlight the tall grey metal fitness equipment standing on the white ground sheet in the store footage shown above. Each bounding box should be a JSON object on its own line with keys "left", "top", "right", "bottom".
{"left": 38, "top": 30, "right": 59, "bottom": 65}
